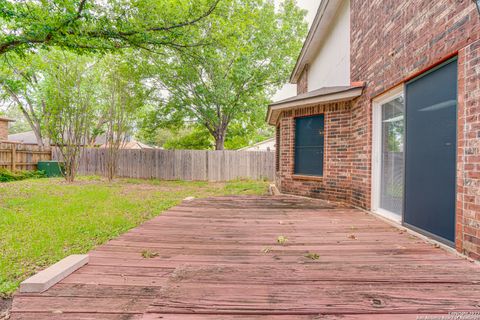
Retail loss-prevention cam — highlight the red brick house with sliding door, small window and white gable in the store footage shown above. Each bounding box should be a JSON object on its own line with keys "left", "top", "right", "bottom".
{"left": 267, "top": 0, "right": 480, "bottom": 260}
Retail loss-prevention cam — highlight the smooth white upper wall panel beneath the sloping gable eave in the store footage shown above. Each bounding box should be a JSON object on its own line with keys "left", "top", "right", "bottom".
{"left": 308, "top": 0, "right": 350, "bottom": 91}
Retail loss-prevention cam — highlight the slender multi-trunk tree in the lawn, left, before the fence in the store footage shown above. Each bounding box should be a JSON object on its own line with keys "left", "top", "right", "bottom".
{"left": 42, "top": 51, "right": 100, "bottom": 182}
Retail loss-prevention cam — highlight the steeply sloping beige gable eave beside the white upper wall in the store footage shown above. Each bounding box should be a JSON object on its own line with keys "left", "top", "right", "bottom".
{"left": 290, "top": 0, "right": 344, "bottom": 84}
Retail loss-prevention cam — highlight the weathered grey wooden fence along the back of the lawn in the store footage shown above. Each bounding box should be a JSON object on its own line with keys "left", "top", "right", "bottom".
{"left": 53, "top": 149, "right": 275, "bottom": 181}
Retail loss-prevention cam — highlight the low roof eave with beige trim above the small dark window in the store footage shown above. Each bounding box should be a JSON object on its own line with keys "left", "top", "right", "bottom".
{"left": 267, "top": 83, "right": 364, "bottom": 125}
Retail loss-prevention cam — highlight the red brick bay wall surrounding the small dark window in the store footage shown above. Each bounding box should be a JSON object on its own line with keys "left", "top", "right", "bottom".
{"left": 277, "top": 103, "right": 351, "bottom": 202}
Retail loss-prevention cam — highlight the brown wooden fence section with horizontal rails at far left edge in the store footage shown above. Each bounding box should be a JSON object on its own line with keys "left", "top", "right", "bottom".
{"left": 0, "top": 142, "right": 52, "bottom": 170}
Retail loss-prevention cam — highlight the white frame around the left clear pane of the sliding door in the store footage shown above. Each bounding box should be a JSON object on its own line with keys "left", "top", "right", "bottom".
{"left": 371, "top": 84, "right": 405, "bottom": 223}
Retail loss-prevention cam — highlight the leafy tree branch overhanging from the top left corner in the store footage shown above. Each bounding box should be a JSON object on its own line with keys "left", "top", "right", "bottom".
{"left": 0, "top": 0, "right": 219, "bottom": 55}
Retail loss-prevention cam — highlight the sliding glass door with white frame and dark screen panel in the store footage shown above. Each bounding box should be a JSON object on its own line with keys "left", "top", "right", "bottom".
{"left": 372, "top": 58, "right": 458, "bottom": 246}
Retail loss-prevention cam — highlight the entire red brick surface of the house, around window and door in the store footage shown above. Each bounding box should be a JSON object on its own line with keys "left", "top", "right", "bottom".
{"left": 277, "top": 0, "right": 480, "bottom": 259}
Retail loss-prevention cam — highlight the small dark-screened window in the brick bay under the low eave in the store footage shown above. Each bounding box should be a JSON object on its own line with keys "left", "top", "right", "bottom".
{"left": 295, "top": 114, "right": 325, "bottom": 176}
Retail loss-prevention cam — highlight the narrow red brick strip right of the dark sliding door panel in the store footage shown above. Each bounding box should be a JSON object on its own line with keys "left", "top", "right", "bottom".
{"left": 456, "top": 41, "right": 480, "bottom": 260}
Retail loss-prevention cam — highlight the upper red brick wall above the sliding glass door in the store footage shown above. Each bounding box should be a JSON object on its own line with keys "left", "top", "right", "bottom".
{"left": 351, "top": 0, "right": 480, "bottom": 98}
